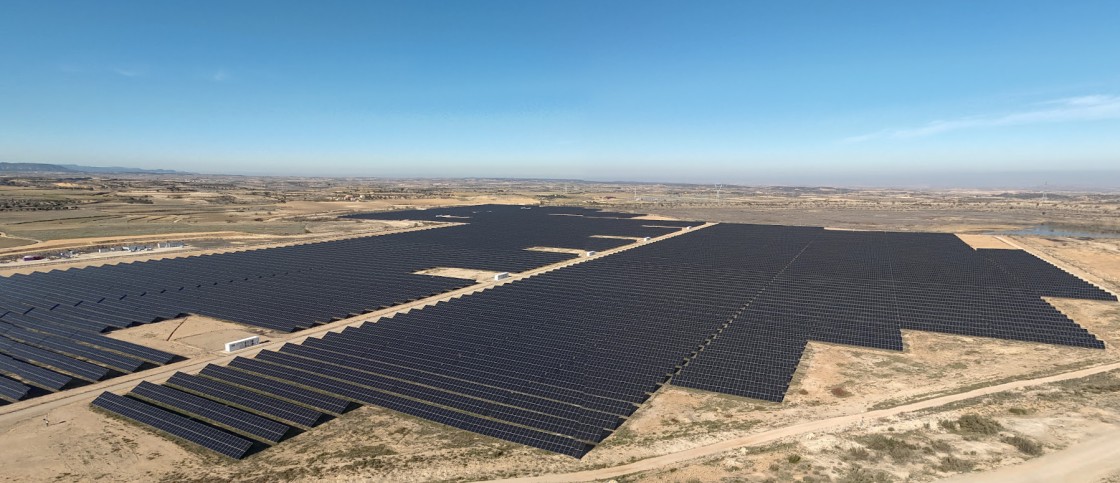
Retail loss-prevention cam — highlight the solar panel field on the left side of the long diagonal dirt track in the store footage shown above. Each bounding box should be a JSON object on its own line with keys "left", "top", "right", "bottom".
{"left": 0, "top": 205, "right": 680, "bottom": 399}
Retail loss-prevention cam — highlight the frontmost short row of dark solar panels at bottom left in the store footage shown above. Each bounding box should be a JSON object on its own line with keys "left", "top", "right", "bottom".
{"left": 91, "top": 392, "right": 253, "bottom": 459}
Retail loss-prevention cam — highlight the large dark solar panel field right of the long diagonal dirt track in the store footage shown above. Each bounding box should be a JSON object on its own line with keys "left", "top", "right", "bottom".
{"left": 87, "top": 220, "right": 1111, "bottom": 457}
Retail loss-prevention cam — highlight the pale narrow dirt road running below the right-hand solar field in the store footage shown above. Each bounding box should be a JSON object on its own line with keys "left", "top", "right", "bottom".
{"left": 488, "top": 362, "right": 1120, "bottom": 483}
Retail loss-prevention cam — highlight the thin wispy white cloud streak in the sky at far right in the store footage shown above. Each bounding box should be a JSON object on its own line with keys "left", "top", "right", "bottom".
{"left": 843, "top": 95, "right": 1120, "bottom": 143}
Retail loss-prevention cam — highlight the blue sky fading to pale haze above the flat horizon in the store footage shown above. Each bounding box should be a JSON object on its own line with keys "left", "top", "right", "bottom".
{"left": 0, "top": 1, "right": 1120, "bottom": 186}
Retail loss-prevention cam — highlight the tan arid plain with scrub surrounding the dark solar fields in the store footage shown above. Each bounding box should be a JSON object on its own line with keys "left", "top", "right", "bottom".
{"left": 0, "top": 175, "right": 1120, "bottom": 482}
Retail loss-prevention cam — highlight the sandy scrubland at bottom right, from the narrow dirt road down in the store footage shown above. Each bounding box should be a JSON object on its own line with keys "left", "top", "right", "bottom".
{"left": 535, "top": 363, "right": 1120, "bottom": 483}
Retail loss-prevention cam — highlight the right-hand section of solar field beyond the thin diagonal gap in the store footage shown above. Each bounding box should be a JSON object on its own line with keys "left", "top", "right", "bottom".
{"left": 673, "top": 225, "right": 1116, "bottom": 401}
